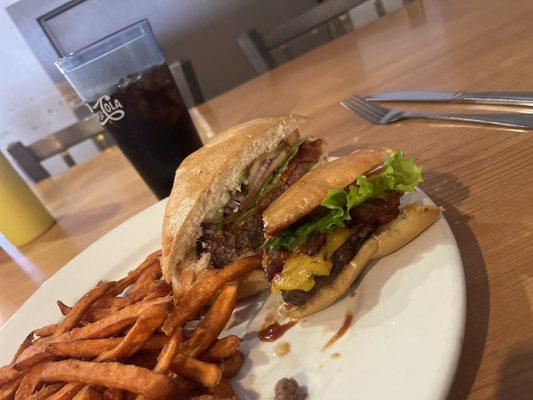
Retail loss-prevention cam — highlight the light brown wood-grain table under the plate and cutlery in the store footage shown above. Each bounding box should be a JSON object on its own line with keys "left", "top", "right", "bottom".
{"left": 0, "top": 0, "right": 533, "bottom": 399}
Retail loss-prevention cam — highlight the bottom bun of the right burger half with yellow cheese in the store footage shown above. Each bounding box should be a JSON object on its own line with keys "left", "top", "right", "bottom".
{"left": 280, "top": 204, "right": 442, "bottom": 318}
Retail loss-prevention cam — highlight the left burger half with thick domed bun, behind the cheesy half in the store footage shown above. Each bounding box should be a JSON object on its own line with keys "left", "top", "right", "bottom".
{"left": 162, "top": 115, "right": 323, "bottom": 298}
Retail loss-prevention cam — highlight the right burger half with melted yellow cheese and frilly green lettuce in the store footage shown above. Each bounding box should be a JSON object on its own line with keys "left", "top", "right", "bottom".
{"left": 263, "top": 149, "right": 441, "bottom": 318}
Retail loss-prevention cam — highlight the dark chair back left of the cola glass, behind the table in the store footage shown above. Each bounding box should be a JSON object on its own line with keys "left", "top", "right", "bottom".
{"left": 7, "top": 117, "right": 115, "bottom": 182}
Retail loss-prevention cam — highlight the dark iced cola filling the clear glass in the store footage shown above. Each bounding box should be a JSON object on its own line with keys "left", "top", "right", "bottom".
{"left": 90, "top": 64, "right": 202, "bottom": 199}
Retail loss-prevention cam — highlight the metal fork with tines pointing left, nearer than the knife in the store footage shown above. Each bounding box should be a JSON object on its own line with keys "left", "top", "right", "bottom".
{"left": 341, "top": 95, "right": 533, "bottom": 129}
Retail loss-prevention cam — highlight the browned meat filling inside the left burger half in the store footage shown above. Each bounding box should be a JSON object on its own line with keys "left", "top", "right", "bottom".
{"left": 196, "top": 140, "right": 322, "bottom": 268}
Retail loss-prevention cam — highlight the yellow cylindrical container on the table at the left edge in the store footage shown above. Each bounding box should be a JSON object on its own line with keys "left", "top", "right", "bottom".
{"left": 0, "top": 152, "right": 54, "bottom": 246}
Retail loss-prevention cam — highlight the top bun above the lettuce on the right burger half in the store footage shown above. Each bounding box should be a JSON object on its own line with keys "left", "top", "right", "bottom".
{"left": 263, "top": 148, "right": 393, "bottom": 236}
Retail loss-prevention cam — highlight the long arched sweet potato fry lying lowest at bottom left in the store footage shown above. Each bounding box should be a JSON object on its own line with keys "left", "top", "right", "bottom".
{"left": 15, "top": 360, "right": 178, "bottom": 400}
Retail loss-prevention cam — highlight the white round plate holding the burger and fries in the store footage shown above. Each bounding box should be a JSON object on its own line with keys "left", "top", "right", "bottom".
{"left": 0, "top": 193, "right": 466, "bottom": 400}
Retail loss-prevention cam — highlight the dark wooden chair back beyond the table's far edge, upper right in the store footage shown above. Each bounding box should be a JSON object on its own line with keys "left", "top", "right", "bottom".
{"left": 237, "top": 0, "right": 411, "bottom": 74}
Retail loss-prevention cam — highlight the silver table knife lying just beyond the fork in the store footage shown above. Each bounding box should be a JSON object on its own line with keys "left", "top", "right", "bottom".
{"left": 366, "top": 91, "right": 533, "bottom": 106}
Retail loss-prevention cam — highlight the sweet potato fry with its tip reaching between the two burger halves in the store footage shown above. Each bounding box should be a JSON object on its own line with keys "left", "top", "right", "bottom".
{"left": 163, "top": 256, "right": 261, "bottom": 335}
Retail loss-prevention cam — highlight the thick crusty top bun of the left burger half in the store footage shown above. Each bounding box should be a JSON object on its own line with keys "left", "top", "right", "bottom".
{"left": 161, "top": 115, "right": 305, "bottom": 294}
